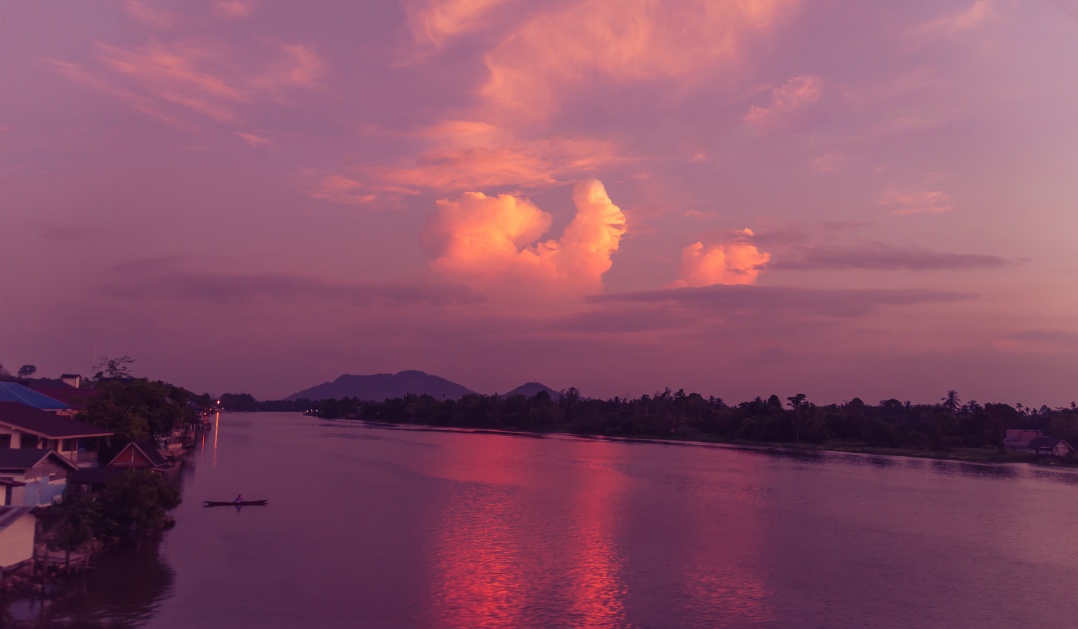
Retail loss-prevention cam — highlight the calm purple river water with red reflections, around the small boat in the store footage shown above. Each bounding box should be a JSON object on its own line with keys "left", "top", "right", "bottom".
{"left": 9, "top": 413, "right": 1078, "bottom": 628}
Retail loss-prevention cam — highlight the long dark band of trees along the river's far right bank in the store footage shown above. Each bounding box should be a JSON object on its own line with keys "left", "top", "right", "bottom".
{"left": 221, "top": 388, "right": 1078, "bottom": 467}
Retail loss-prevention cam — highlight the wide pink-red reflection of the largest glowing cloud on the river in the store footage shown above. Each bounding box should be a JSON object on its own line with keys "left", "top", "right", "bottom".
{"left": 430, "top": 438, "right": 630, "bottom": 627}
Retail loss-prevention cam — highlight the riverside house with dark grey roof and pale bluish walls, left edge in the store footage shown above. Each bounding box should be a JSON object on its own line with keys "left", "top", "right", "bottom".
{"left": 0, "top": 448, "right": 79, "bottom": 507}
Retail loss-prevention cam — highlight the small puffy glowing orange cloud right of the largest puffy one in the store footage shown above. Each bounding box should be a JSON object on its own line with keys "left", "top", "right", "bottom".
{"left": 671, "top": 230, "right": 771, "bottom": 288}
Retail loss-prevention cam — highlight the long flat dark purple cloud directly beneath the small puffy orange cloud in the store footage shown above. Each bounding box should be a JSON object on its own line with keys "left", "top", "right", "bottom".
{"left": 588, "top": 285, "right": 977, "bottom": 317}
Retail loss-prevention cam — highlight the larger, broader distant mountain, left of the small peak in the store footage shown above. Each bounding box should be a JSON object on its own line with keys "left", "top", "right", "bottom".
{"left": 285, "top": 371, "right": 475, "bottom": 401}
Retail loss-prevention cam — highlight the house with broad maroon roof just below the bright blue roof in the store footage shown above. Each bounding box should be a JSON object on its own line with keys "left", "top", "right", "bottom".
{"left": 0, "top": 401, "right": 112, "bottom": 465}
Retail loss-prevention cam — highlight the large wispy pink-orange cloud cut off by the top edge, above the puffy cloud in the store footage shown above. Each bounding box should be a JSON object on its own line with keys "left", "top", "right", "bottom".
{"left": 481, "top": 0, "right": 798, "bottom": 120}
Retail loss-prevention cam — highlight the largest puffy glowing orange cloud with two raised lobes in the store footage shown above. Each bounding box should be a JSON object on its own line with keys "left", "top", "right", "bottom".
{"left": 423, "top": 180, "right": 626, "bottom": 295}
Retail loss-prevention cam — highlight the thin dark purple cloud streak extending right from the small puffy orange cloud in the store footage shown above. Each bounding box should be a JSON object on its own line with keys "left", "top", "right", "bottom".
{"left": 770, "top": 243, "right": 1010, "bottom": 271}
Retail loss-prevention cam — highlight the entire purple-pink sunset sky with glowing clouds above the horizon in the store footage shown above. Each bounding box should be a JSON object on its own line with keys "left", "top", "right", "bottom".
{"left": 0, "top": 0, "right": 1078, "bottom": 407}
